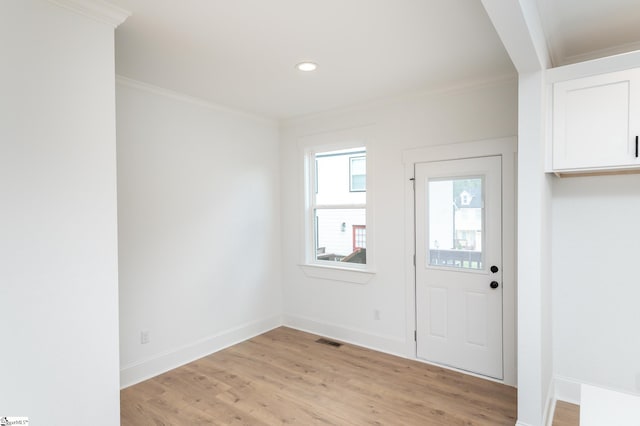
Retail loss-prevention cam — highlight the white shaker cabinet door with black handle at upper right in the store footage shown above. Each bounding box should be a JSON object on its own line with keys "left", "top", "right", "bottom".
{"left": 553, "top": 69, "right": 640, "bottom": 170}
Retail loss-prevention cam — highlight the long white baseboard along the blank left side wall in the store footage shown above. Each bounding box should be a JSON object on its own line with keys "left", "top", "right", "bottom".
{"left": 120, "top": 315, "right": 282, "bottom": 389}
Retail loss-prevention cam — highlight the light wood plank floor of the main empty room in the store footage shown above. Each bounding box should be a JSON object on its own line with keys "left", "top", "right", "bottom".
{"left": 121, "top": 327, "right": 516, "bottom": 426}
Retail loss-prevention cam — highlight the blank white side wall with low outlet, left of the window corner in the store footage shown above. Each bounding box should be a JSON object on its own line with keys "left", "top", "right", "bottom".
{"left": 117, "top": 79, "right": 282, "bottom": 386}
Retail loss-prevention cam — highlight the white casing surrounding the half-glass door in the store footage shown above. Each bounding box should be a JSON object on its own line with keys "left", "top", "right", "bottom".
{"left": 402, "top": 137, "right": 517, "bottom": 386}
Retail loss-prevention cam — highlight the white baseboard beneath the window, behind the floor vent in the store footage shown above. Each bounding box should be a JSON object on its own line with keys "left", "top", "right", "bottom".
{"left": 283, "top": 314, "right": 409, "bottom": 358}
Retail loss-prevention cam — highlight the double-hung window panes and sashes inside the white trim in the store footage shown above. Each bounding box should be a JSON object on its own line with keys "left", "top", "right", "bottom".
{"left": 307, "top": 147, "right": 367, "bottom": 268}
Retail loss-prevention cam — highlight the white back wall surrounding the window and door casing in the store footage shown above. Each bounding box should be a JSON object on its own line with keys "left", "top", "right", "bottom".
{"left": 281, "top": 80, "right": 517, "bottom": 356}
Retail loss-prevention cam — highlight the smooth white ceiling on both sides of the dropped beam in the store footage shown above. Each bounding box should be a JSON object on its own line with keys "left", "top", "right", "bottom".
{"left": 110, "top": 0, "right": 640, "bottom": 119}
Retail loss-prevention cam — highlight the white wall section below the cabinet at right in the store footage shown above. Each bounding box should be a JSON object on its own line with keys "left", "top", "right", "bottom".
{"left": 553, "top": 175, "right": 640, "bottom": 394}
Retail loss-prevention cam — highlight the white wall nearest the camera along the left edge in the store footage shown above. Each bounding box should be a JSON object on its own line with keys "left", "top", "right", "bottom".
{"left": 0, "top": 0, "right": 120, "bottom": 425}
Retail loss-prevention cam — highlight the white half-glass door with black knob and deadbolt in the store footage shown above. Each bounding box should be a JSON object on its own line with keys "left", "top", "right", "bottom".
{"left": 415, "top": 156, "right": 503, "bottom": 379}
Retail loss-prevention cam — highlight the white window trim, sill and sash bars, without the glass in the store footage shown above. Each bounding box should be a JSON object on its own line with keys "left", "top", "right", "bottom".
{"left": 300, "top": 135, "right": 375, "bottom": 284}
